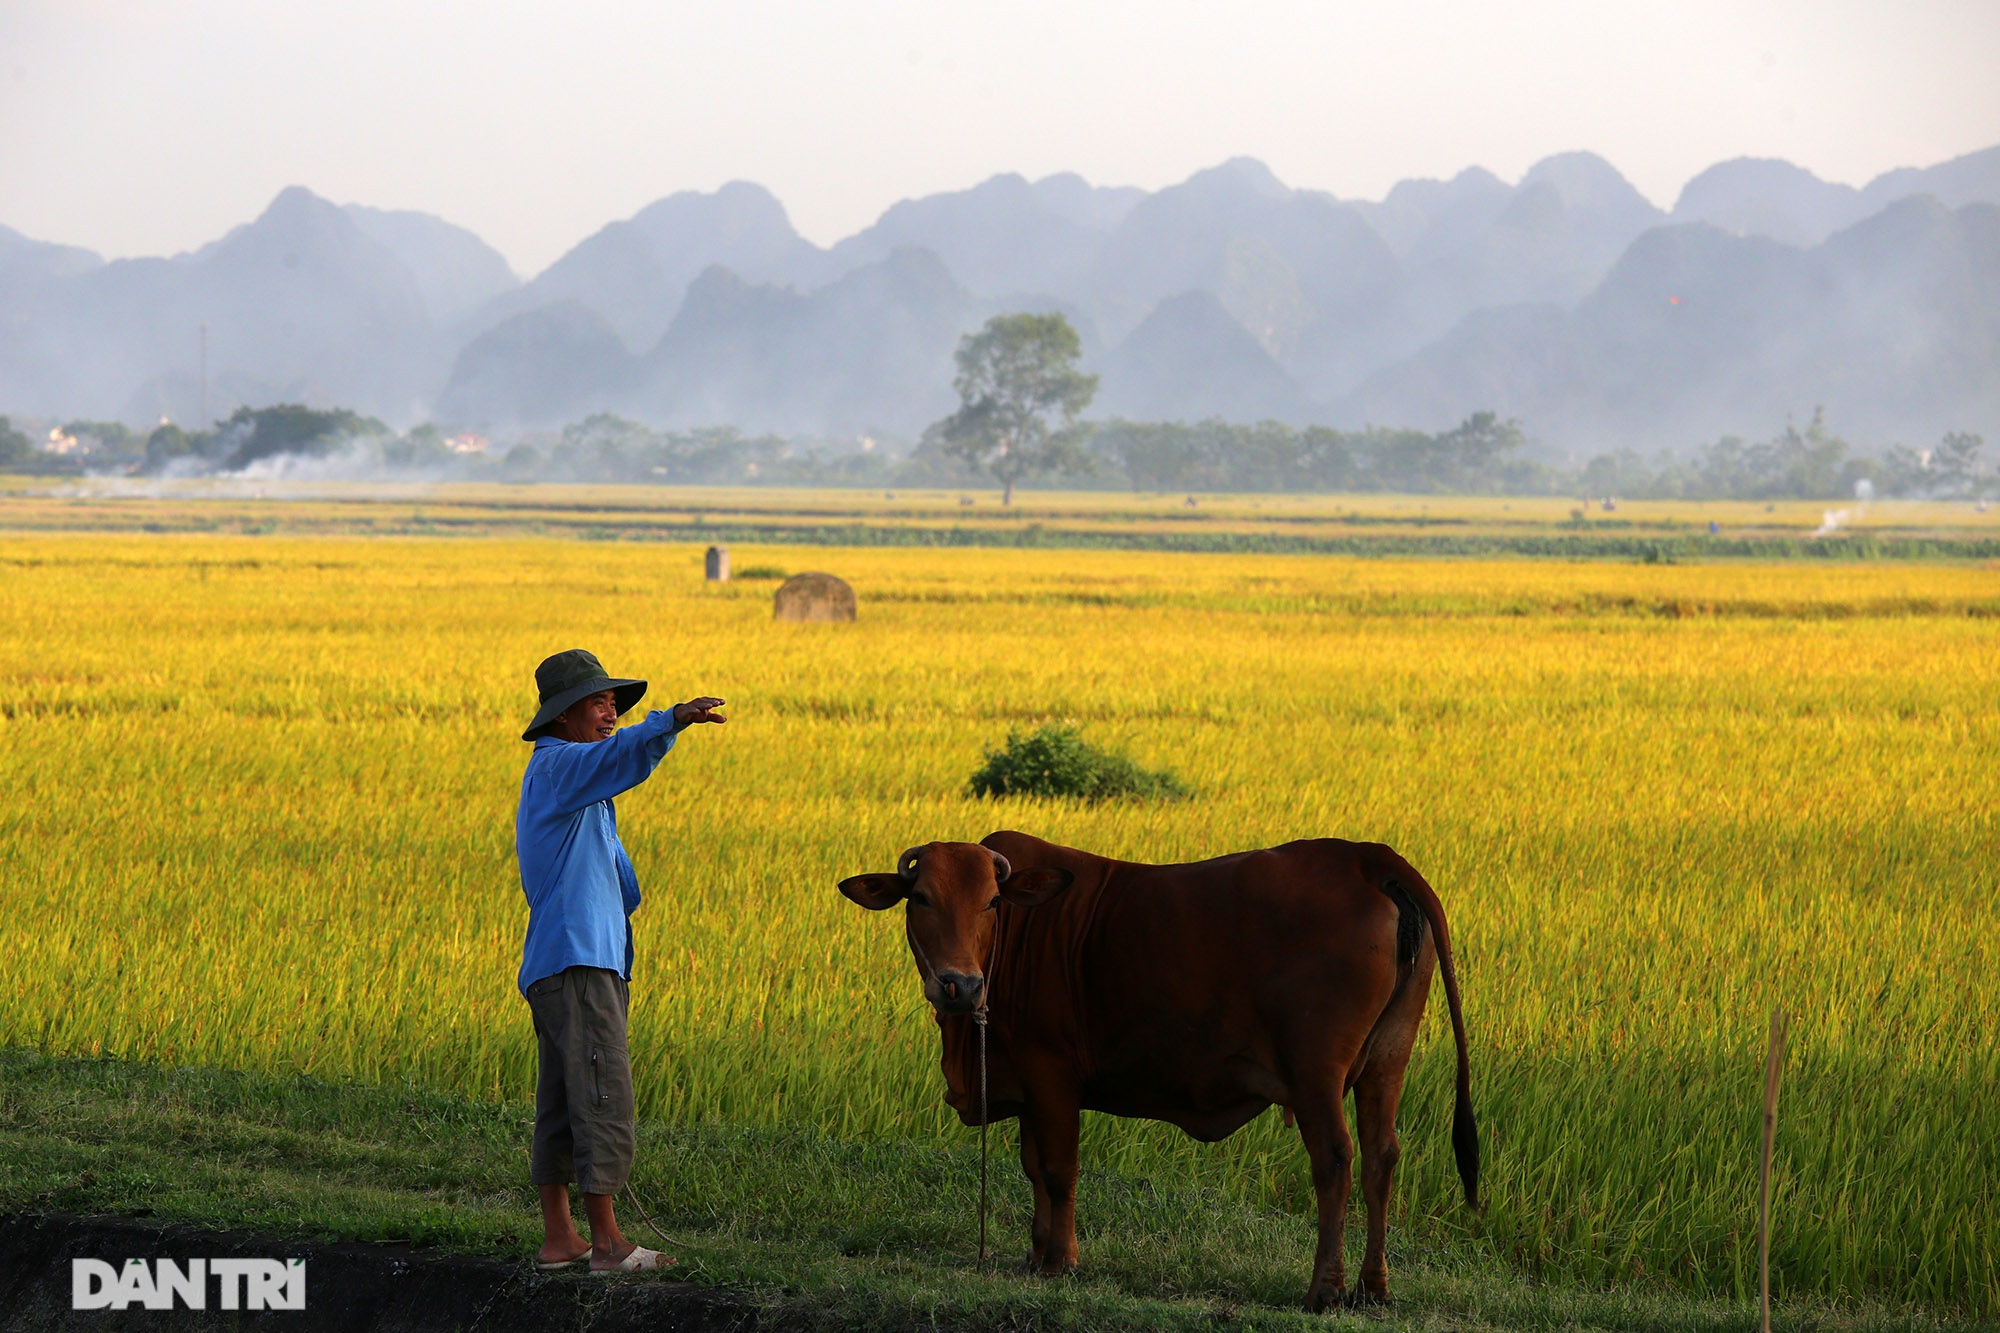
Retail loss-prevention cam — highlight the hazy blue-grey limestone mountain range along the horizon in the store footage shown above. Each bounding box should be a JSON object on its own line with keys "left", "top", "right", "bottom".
{"left": 0, "top": 146, "right": 2000, "bottom": 452}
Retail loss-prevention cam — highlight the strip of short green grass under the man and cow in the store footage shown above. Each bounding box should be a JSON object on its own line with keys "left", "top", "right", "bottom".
{"left": 0, "top": 1049, "right": 1972, "bottom": 1333}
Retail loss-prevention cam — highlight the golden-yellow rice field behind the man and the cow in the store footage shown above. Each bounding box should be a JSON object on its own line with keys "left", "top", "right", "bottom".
{"left": 0, "top": 534, "right": 2000, "bottom": 1315}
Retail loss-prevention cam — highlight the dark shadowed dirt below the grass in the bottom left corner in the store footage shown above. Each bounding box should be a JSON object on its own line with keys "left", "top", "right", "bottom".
{"left": 0, "top": 1215, "right": 774, "bottom": 1333}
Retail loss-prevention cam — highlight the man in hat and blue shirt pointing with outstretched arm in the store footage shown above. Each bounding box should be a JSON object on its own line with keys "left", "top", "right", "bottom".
{"left": 514, "top": 648, "right": 728, "bottom": 1273}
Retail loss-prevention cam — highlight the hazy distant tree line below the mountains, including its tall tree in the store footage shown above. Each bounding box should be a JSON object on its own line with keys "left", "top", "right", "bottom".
{"left": 0, "top": 314, "right": 2000, "bottom": 504}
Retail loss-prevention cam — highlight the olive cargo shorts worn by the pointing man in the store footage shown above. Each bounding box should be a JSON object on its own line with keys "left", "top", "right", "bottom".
{"left": 528, "top": 967, "right": 638, "bottom": 1195}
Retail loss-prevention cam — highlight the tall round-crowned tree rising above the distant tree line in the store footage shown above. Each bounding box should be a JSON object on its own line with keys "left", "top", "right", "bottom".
{"left": 924, "top": 314, "right": 1098, "bottom": 504}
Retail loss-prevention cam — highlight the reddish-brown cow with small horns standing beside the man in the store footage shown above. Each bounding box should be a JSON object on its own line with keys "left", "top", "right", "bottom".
{"left": 840, "top": 833, "right": 1480, "bottom": 1309}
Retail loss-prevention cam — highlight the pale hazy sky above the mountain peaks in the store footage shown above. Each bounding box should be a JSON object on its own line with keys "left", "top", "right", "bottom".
{"left": 0, "top": 0, "right": 2000, "bottom": 274}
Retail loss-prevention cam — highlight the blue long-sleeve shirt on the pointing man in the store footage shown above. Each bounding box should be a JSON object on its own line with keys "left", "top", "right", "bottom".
{"left": 514, "top": 711, "right": 680, "bottom": 993}
